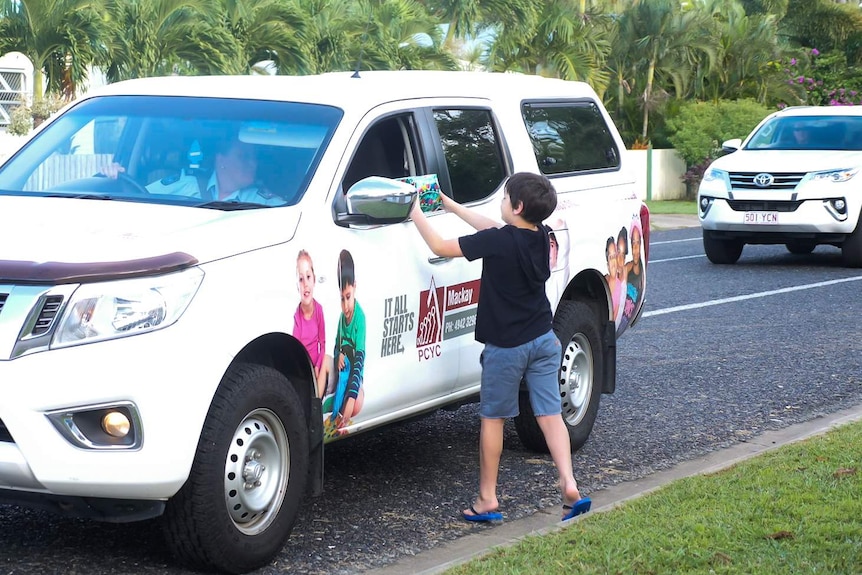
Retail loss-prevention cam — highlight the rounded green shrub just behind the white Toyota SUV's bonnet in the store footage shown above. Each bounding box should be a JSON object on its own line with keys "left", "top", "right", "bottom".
{"left": 667, "top": 100, "right": 771, "bottom": 167}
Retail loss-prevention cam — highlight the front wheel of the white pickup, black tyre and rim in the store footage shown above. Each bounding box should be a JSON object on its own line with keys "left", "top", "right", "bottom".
{"left": 164, "top": 364, "right": 308, "bottom": 573}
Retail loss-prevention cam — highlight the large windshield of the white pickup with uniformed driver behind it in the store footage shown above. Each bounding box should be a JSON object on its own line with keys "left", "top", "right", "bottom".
{"left": 0, "top": 96, "right": 342, "bottom": 209}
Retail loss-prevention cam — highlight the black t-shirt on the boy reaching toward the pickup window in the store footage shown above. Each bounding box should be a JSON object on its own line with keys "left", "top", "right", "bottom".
{"left": 458, "top": 226, "right": 553, "bottom": 347}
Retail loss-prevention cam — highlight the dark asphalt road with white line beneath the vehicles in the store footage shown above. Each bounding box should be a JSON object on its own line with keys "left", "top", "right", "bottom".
{"left": 0, "top": 228, "right": 862, "bottom": 575}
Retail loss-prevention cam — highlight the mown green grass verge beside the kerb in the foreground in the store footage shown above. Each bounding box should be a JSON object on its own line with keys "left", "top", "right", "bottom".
{"left": 445, "top": 423, "right": 862, "bottom": 575}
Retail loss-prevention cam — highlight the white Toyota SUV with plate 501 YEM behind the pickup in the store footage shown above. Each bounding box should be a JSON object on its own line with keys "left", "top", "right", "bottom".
{"left": 698, "top": 106, "right": 862, "bottom": 267}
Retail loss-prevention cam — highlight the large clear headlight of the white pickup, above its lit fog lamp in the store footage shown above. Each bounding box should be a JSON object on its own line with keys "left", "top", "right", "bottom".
{"left": 51, "top": 268, "right": 204, "bottom": 348}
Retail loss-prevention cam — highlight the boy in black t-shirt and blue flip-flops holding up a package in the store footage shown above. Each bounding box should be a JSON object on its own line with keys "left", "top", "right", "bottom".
{"left": 411, "top": 172, "right": 590, "bottom": 521}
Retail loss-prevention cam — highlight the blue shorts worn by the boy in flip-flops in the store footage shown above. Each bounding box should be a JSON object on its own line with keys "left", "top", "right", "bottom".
{"left": 479, "top": 331, "right": 562, "bottom": 419}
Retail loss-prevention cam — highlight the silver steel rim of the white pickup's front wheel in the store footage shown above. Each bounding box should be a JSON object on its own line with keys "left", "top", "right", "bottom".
{"left": 224, "top": 409, "right": 290, "bottom": 535}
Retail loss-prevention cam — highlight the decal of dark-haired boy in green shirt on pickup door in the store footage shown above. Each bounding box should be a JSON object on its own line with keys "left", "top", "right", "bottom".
{"left": 318, "top": 250, "right": 365, "bottom": 437}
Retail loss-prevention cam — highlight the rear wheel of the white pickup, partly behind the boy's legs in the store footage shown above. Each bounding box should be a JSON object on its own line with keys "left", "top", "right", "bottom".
{"left": 515, "top": 301, "right": 604, "bottom": 453}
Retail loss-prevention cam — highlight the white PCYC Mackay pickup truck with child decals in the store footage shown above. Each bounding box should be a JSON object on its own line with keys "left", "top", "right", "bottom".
{"left": 0, "top": 71, "right": 649, "bottom": 573}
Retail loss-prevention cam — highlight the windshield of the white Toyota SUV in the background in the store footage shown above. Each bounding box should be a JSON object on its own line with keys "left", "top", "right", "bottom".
{"left": 745, "top": 116, "right": 862, "bottom": 151}
